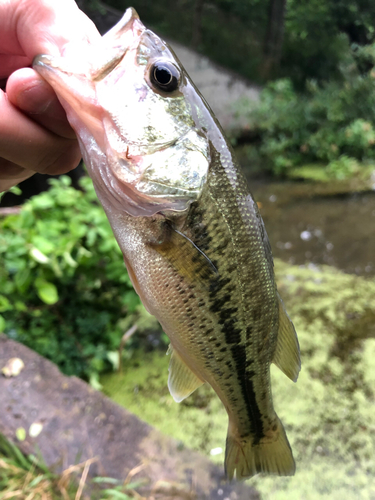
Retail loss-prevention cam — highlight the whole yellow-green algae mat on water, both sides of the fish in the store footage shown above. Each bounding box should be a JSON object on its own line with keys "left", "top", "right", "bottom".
{"left": 102, "top": 261, "right": 375, "bottom": 500}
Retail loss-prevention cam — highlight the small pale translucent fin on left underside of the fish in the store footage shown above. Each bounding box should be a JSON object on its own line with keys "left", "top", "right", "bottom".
{"left": 167, "top": 345, "right": 204, "bottom": 403}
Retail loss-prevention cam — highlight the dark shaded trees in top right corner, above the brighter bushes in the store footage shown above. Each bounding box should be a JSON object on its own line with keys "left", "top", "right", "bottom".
{"left": 281, "top": 0, "right": 375, "bottom": 88}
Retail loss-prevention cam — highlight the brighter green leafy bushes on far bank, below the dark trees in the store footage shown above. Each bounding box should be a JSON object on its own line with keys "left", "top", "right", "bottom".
{"left": 238, "top": 54, "right": 375, "bottom": 179}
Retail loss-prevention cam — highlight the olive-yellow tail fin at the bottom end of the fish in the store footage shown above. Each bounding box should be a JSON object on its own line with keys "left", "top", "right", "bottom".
{"left": 225, "top": 417, "right": 296, "bottom": 480}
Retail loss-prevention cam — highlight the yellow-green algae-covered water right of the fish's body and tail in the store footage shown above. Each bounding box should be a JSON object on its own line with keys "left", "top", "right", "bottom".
{"left": 266, "top": 262, "right": 375, "bottom": 500}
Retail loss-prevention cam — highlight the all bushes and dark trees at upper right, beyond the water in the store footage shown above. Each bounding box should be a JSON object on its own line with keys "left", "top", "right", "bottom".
{"left": 226, "top": 0, "right": 375, "bottom": 180}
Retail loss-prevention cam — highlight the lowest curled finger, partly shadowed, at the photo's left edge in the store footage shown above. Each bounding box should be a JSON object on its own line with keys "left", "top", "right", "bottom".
{"left": 0, "top": 91, "right": 81, "bottom": 177}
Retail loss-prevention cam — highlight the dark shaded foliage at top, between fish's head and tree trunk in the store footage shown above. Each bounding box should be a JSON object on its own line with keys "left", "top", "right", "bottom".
{"left": 106, "top": 0, "right": 267, "bottom": 80}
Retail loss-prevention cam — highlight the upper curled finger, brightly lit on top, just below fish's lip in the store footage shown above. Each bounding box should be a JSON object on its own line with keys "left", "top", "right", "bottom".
{"left": 6, "top": 68, "right": 76, "bottom": 139}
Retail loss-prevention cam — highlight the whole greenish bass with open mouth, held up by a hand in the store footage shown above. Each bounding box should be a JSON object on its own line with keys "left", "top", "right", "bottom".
{"left": 33, "top": 8, "right": 301, "bottom": 480}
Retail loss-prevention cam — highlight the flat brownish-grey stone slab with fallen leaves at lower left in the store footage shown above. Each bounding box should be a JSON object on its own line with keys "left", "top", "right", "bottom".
{"left": 0, "top": 335, "right": 259, "bottom": 500}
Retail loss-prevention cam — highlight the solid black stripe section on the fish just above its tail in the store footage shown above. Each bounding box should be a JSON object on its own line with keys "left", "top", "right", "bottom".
{"left": 230, "top": 345, "right": 264, "bottom": 444}
